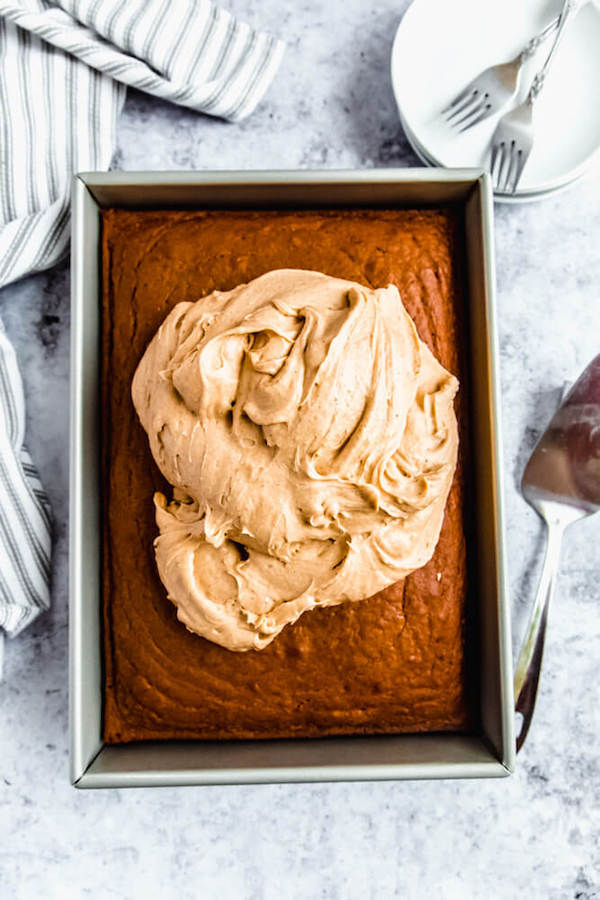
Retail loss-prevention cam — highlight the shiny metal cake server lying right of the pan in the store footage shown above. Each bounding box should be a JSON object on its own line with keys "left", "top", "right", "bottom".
{"left": 515, "top": 354, "right": 600, "bottom": 752}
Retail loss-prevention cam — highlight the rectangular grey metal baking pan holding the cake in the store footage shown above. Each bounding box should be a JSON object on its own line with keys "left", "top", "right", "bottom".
{"left": 69, "top": 169, "right": 515, "bottom": 788}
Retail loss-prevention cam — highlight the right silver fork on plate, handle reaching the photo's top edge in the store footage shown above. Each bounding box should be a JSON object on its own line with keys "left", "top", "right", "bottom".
{"left": 490, "top": 0, "right": 577, "bottom": 194}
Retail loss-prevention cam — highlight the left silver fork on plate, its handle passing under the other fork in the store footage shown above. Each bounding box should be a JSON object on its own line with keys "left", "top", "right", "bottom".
{"left": 442, "top": 16, "right": 560, "bottom": 131}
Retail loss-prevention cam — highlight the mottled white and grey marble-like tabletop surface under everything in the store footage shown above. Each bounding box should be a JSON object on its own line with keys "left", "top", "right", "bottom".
{"left": 0, "top": 0, "right": 600, "bottom": 900}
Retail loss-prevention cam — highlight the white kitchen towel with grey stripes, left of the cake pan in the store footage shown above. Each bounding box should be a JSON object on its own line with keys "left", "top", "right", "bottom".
{"left": 0, "top": 0, "right": 284, "bottom": 672}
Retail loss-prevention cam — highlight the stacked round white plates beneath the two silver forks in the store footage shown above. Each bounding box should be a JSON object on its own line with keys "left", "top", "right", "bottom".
{"left": 392, "top": 0, "right": 600, "bottom": 202}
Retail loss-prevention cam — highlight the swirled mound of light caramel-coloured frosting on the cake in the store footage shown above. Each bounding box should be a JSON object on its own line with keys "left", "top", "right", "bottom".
{"left": 132, "top": 269, "right": 458, "bottom": 651}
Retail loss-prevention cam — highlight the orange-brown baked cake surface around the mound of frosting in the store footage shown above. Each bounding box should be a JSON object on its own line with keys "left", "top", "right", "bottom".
{"left": 103, "top": 210, "right": 469, "bottom": 742}
